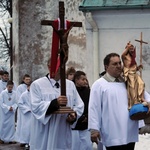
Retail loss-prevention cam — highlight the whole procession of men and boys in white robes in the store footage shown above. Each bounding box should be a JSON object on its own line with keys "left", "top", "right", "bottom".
{"left": 0, "top": 42, "right": 150, "bottom": 150}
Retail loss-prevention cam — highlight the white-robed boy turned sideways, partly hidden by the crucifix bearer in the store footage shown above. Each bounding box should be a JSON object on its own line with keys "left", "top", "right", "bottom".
{"left": 18, "top": 85, "right": 32, "bottom": 146}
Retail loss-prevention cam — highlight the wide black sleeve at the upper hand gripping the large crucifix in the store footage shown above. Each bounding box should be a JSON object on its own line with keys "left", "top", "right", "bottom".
{"left": 46, "top": 99, "right": 59, "bottom": 115}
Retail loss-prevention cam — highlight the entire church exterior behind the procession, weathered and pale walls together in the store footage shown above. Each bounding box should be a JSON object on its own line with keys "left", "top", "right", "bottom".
{"left": 13, "top": 0, "right": 150, "bottom": 92}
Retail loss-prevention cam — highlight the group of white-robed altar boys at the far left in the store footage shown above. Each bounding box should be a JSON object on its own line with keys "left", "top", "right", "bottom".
{"left": 0, "top": 71, "right": 31, "bottom": 147}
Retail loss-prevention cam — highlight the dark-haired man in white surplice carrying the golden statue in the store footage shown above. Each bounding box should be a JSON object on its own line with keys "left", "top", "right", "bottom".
{"left": 88, "top": 53, "right": 150, "bottom": 150}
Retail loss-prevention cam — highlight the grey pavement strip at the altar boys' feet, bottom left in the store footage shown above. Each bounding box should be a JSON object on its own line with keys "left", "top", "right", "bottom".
{"left": 0, "top": 143, "right": 24, "bottom": 150}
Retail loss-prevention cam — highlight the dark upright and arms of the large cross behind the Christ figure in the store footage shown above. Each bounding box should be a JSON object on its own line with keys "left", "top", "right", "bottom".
{"left": 41, "top": 1, "right": 82, "bottom": 96}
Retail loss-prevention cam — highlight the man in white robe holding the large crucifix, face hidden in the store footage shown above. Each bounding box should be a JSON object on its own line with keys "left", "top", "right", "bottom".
{"left": 30, "top": 60, "right": 84, "bottom": 150}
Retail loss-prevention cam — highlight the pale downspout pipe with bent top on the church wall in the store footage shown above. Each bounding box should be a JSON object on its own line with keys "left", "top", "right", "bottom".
{"left": 85, "top": 12, "right": 99, "bottom": 82}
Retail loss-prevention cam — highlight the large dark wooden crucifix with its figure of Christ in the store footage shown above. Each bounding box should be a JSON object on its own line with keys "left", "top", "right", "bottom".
{"left": 41, "top": 1, "right": 82, "bottom": 113}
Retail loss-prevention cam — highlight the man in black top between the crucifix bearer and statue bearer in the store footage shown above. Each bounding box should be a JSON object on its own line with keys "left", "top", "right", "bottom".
{"left": 72, "top": 71, "right": 92, "bottom": 150}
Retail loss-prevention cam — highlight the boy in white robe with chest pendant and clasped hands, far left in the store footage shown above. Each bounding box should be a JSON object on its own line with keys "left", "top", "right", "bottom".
{"left": 0, "top": 80, "right": 17, "bottom": 143}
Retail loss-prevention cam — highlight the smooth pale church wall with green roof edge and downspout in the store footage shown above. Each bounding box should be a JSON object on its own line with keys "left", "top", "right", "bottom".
{"left": 79, "top": 0, "right": 150, "bottom": 92}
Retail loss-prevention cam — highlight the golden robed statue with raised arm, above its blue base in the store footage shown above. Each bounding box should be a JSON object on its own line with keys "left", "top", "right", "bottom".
{"left": 122, "top": 42, "right": 146, "bottom": 109}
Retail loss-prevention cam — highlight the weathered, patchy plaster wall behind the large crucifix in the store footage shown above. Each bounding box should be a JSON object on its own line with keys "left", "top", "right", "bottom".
{"left": 13, "top": 0, "right": 88, "bottom": 84}
